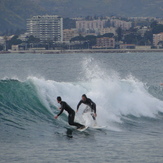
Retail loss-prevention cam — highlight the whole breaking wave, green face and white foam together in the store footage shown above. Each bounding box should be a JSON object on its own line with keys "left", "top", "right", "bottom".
{"left": 0, "top": 59, "right": 163, "bottom": 134}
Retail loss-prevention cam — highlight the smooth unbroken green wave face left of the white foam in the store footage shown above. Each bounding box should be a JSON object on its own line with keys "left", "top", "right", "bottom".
{"left": 0, "top": 79, "right": 54, "bottom": 133}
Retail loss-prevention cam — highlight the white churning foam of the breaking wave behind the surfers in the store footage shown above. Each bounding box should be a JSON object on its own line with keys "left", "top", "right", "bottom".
{"left": 29, "top": 57, "right": 163, "bottom": 131}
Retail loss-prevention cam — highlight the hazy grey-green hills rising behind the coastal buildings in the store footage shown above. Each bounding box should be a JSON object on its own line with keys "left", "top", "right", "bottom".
{"left": 0, "top": 0, "right": 163, "bottom": 31}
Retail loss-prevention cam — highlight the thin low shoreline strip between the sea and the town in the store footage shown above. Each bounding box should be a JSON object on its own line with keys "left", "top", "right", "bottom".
{"left": 0, "top": 49, "right": 163, "bottom": 54}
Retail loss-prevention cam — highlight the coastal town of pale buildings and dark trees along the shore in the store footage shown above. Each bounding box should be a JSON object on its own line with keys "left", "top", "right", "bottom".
{"left": 0, "top": 15, "right": 163, "bottom": 53}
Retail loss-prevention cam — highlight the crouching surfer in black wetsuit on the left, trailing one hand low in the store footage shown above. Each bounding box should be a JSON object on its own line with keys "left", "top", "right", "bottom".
{"left": 54, "top": 97, "right": 85, "bottom": 129}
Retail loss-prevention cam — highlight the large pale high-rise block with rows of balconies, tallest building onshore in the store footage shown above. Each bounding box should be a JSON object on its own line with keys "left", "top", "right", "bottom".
{"left": 27, "top": 15, "right": 63, "bottom": 42}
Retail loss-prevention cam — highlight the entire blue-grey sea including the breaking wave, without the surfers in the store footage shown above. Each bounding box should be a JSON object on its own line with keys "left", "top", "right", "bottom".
{"left": 0, "top": 53, "right": 163, "bottom": 163}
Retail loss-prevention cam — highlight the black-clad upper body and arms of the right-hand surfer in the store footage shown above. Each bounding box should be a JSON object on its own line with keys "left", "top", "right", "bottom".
{"left": 76, "top": 94, "right": 97, "bottom": 120}
